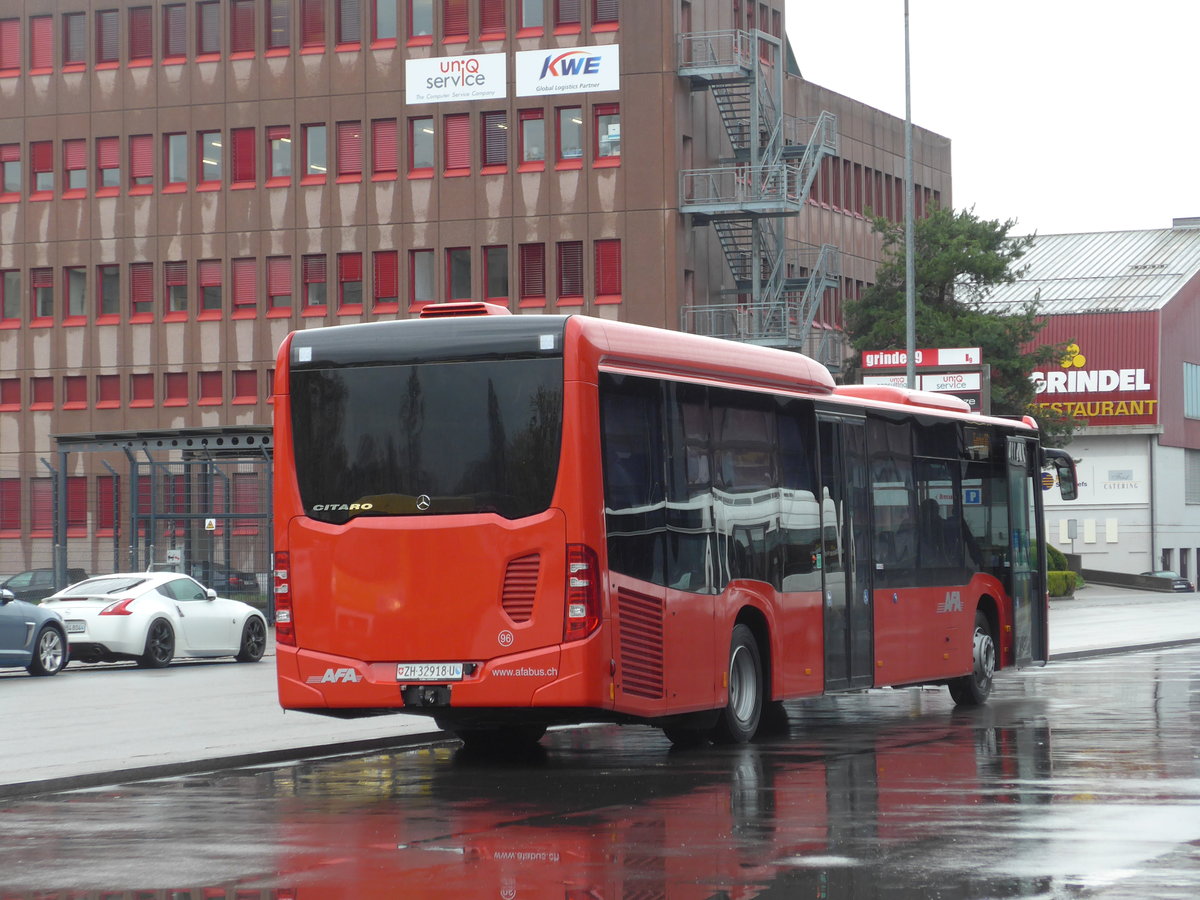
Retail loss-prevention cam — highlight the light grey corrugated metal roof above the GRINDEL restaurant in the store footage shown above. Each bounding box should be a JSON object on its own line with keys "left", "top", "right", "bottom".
{"left": 983, "top": 227, "right": 1200, "bottom": 316}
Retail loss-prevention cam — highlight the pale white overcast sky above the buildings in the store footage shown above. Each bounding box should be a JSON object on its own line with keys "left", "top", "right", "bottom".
{"left": 786, "top": 0, "right": 1200, "bottom": 234}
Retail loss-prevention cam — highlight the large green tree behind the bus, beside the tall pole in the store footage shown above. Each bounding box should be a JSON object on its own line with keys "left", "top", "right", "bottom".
{"left": 845, "top": 209, "right": 1073, "bottom": 443}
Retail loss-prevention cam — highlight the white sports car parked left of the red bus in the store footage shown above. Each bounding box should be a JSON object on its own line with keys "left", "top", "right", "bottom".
{"left": 42, "top": 572, "right": 266, "bottom": 668}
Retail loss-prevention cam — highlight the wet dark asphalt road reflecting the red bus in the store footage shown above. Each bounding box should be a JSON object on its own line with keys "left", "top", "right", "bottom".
{"left": 0, "top": 647, "right": 1200, "bottom": 900}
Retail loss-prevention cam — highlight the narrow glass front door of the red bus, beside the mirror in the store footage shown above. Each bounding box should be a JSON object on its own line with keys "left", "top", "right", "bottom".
{"left": 1007, "top": 437, "right": 1049, "bottom": 667}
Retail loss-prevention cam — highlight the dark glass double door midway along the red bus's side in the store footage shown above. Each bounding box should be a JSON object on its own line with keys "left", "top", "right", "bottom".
{"left": 817, "top": 415, "right": 875, "bottom": 690}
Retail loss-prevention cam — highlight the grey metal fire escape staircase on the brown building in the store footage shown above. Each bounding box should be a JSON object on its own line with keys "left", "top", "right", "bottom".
{"left": 678, "top": 31, "right": 840, "bottom": 361}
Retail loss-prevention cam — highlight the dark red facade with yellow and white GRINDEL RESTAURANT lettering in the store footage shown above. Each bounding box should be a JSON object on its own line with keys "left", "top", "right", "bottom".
{"left": 1032, "top": 313, "right": 1158, "bottom": 425}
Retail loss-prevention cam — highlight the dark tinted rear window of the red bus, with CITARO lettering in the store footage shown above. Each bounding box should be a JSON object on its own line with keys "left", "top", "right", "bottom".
{"left": 290, "top": 356, "right": 563, "bottom": 523}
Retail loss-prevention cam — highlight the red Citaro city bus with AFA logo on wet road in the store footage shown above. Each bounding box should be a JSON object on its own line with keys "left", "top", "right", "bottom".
{"left": 274, "top": 302, "right": 1075, "bottom": 744}
